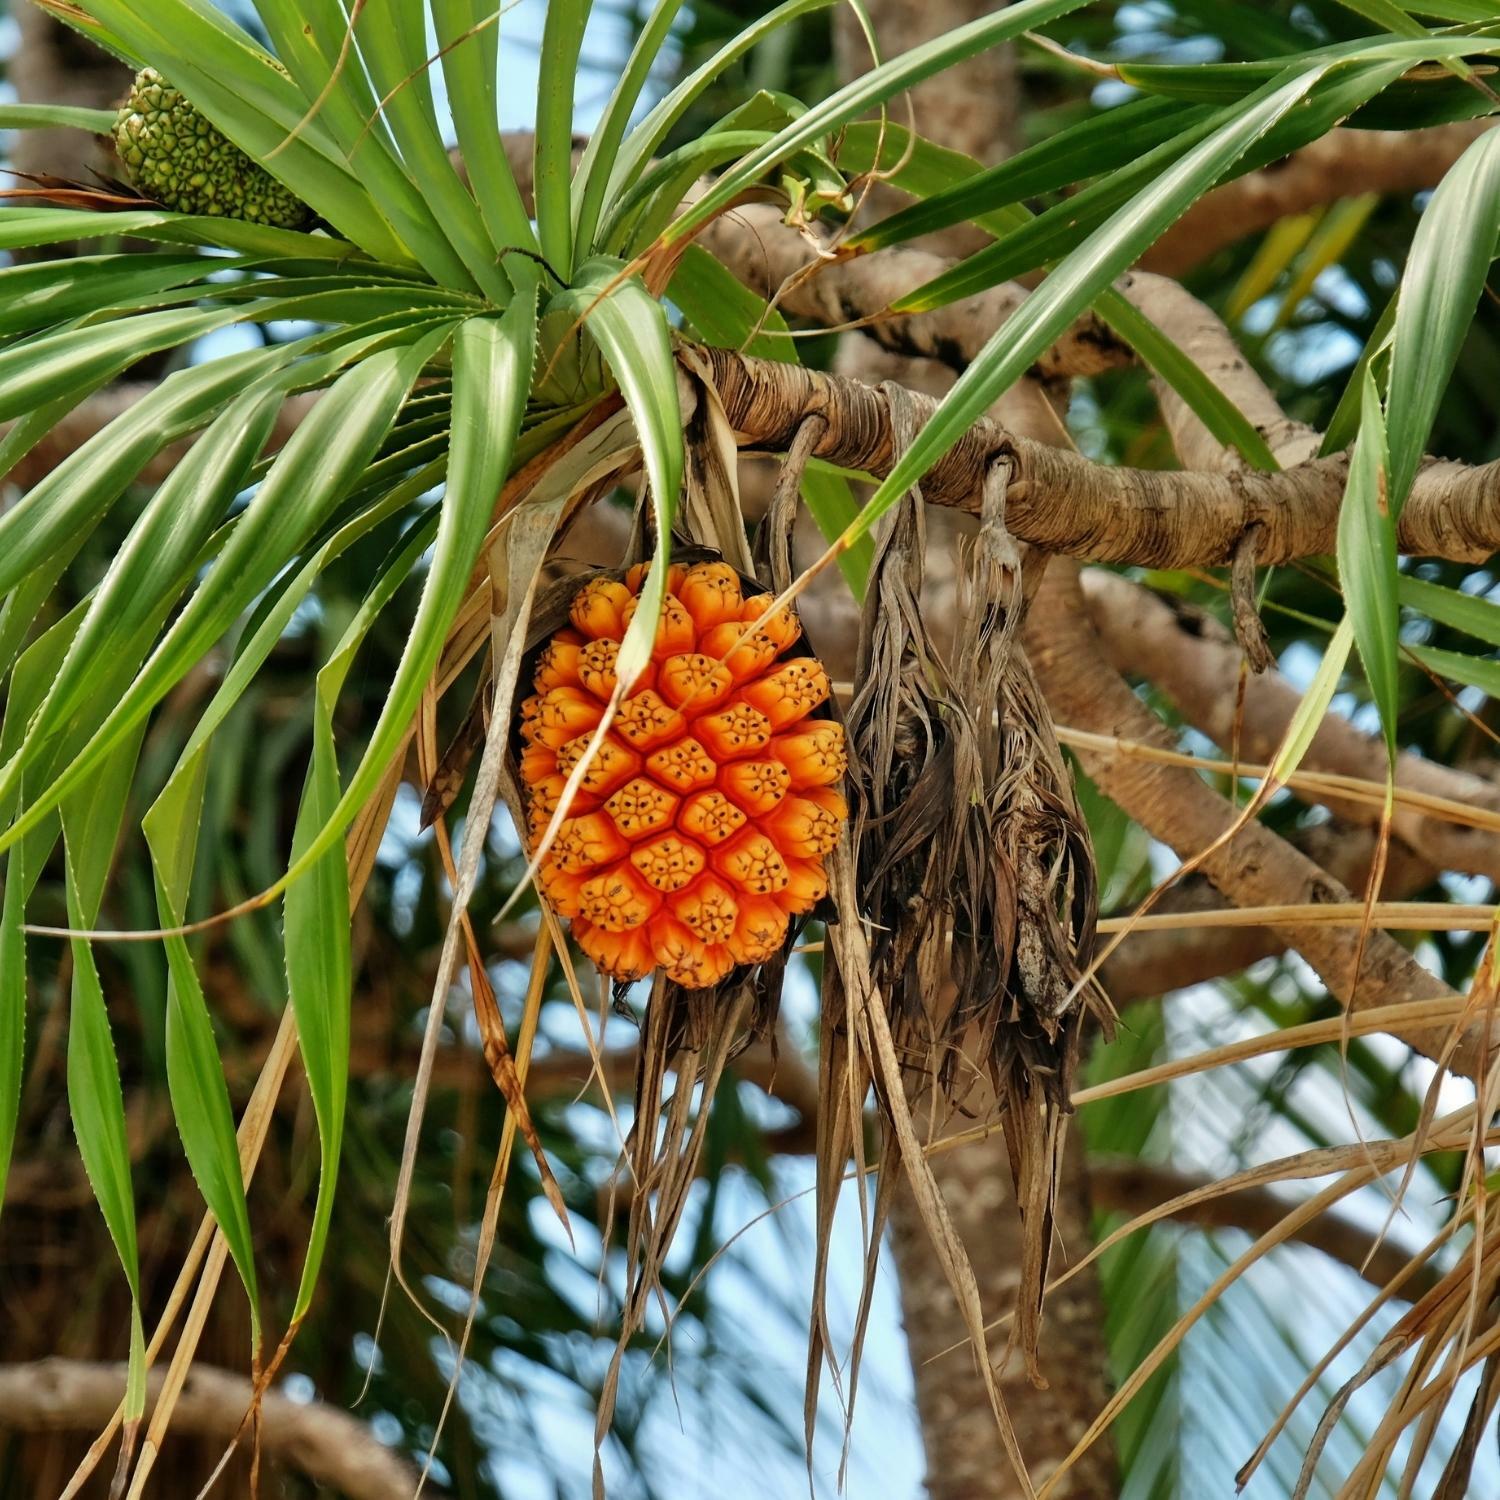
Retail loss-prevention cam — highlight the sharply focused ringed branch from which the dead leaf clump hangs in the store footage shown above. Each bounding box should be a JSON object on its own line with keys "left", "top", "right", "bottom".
{"left": 701, "top": 348, "right": 1500, "bottom": 567}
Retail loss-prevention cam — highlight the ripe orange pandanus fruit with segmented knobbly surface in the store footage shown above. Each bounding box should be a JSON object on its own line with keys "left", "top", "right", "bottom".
{"left": 521, "top": 563, "right": 848, "bottom": 990}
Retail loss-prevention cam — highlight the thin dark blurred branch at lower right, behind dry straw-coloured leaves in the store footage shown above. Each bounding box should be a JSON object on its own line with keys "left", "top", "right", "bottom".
{"left": 1089, "top": 1158, "right": 1437, "bottom": 1302}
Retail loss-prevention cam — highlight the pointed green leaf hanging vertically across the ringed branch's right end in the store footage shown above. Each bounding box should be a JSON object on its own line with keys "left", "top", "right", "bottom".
{"left": 1338, "top": 369, "right": 1401, "bottom": 770}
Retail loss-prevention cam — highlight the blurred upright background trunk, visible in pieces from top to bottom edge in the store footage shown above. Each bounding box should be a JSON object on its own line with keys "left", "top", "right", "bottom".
{"left": 836, "top": 0, "right": 1118, "bottom": 1500}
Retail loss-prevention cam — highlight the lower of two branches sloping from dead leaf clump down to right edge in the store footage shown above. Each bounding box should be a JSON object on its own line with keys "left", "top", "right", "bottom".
{"left": 1026, "top": 560, "right": 1490, "bottom": 1079}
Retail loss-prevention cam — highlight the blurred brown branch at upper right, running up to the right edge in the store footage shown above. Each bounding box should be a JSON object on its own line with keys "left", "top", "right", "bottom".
{"left": 1142, "top": 119, "right": 1497, "bottom": 276}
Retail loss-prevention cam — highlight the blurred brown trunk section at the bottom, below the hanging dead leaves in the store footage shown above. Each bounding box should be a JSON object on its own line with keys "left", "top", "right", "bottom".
{"left": 891, "top": 1122, "right": 1118, "bottom": 1500}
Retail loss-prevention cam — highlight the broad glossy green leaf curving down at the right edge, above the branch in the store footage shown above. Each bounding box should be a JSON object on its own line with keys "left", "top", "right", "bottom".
{"left": 1386, "top": 131, "right": 1500, "bottom": 516}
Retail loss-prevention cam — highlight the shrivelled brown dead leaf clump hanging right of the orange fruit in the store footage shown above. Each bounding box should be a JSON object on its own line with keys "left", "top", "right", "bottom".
{"left": 807, "top": 386, "right": 1109, "bottom": 1470}
